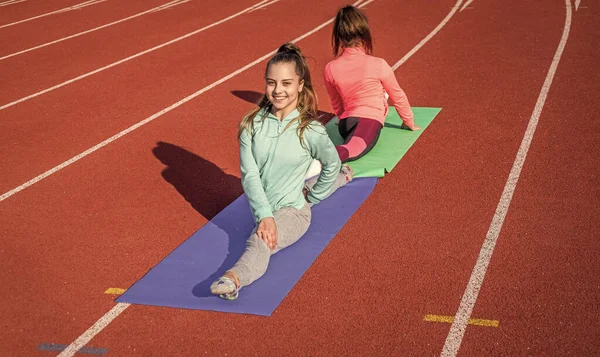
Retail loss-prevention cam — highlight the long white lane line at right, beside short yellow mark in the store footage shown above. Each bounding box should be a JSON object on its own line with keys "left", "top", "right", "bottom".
{"left": 441, "top": 0, "right": 572, "bottom": 357}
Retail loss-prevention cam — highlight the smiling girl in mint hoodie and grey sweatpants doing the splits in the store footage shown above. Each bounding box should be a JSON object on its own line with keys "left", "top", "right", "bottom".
{"left": 210, "top": 43, "right": 352, "bottom": 300}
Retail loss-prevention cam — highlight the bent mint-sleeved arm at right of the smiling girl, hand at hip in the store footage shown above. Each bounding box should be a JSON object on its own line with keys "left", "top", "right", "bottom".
{"left": 304, "top": 123, "right": 342, "bottom": 204}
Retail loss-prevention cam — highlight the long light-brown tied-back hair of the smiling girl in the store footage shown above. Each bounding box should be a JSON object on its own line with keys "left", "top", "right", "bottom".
{"left": 238, "top": 43, "right": 317, "bottom": 146}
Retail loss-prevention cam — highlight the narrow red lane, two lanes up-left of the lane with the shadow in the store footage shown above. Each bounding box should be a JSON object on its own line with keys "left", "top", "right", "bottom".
{"left": 0, "top": 0, "right": 260, "bottom": 104}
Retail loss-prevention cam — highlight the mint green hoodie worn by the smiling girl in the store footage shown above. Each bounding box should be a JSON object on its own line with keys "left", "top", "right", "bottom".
{"left": 240, "top": 109, "right": 342, "bottom": 222}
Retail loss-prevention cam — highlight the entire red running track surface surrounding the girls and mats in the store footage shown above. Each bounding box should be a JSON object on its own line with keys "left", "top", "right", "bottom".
{"left": 0, "top": 0, "right": 600, "bottom": 356}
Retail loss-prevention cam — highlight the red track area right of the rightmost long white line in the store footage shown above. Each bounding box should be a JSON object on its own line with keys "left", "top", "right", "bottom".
{"left": 454, "top": 4, "right": 600, "bottom": 356}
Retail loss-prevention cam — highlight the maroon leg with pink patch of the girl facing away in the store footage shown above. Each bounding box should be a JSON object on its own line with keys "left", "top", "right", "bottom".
{"left": 336, "top": 118, "right": 381, "bottom": 162}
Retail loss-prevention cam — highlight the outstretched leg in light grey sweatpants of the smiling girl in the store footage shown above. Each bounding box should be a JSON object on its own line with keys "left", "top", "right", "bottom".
{"left": 211, "top": 200, "right": 311, "bottom": 298}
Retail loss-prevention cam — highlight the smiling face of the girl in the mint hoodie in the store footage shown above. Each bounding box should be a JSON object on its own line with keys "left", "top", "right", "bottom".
{"left": 265, "top": 62, "right": 304, "bottom": 120}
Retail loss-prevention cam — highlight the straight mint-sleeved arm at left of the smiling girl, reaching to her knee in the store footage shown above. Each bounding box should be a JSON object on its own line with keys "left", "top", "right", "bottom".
{"left": 240, "top": 130, "right": 273, "bottom": 222}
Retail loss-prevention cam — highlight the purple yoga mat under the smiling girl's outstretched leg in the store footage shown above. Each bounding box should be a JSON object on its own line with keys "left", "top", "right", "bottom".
{"left": 116, "top": 178, "right": 377, "bottom": 316}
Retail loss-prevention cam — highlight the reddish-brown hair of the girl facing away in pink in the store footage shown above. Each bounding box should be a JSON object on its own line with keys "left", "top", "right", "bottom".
{"left": 331, "top": 5, "right": 373, "bottom": 57}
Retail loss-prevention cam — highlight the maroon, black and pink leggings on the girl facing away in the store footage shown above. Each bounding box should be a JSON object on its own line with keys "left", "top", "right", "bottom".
{"left": 335, "top": 117, "right": 382, "bottom": 162}
